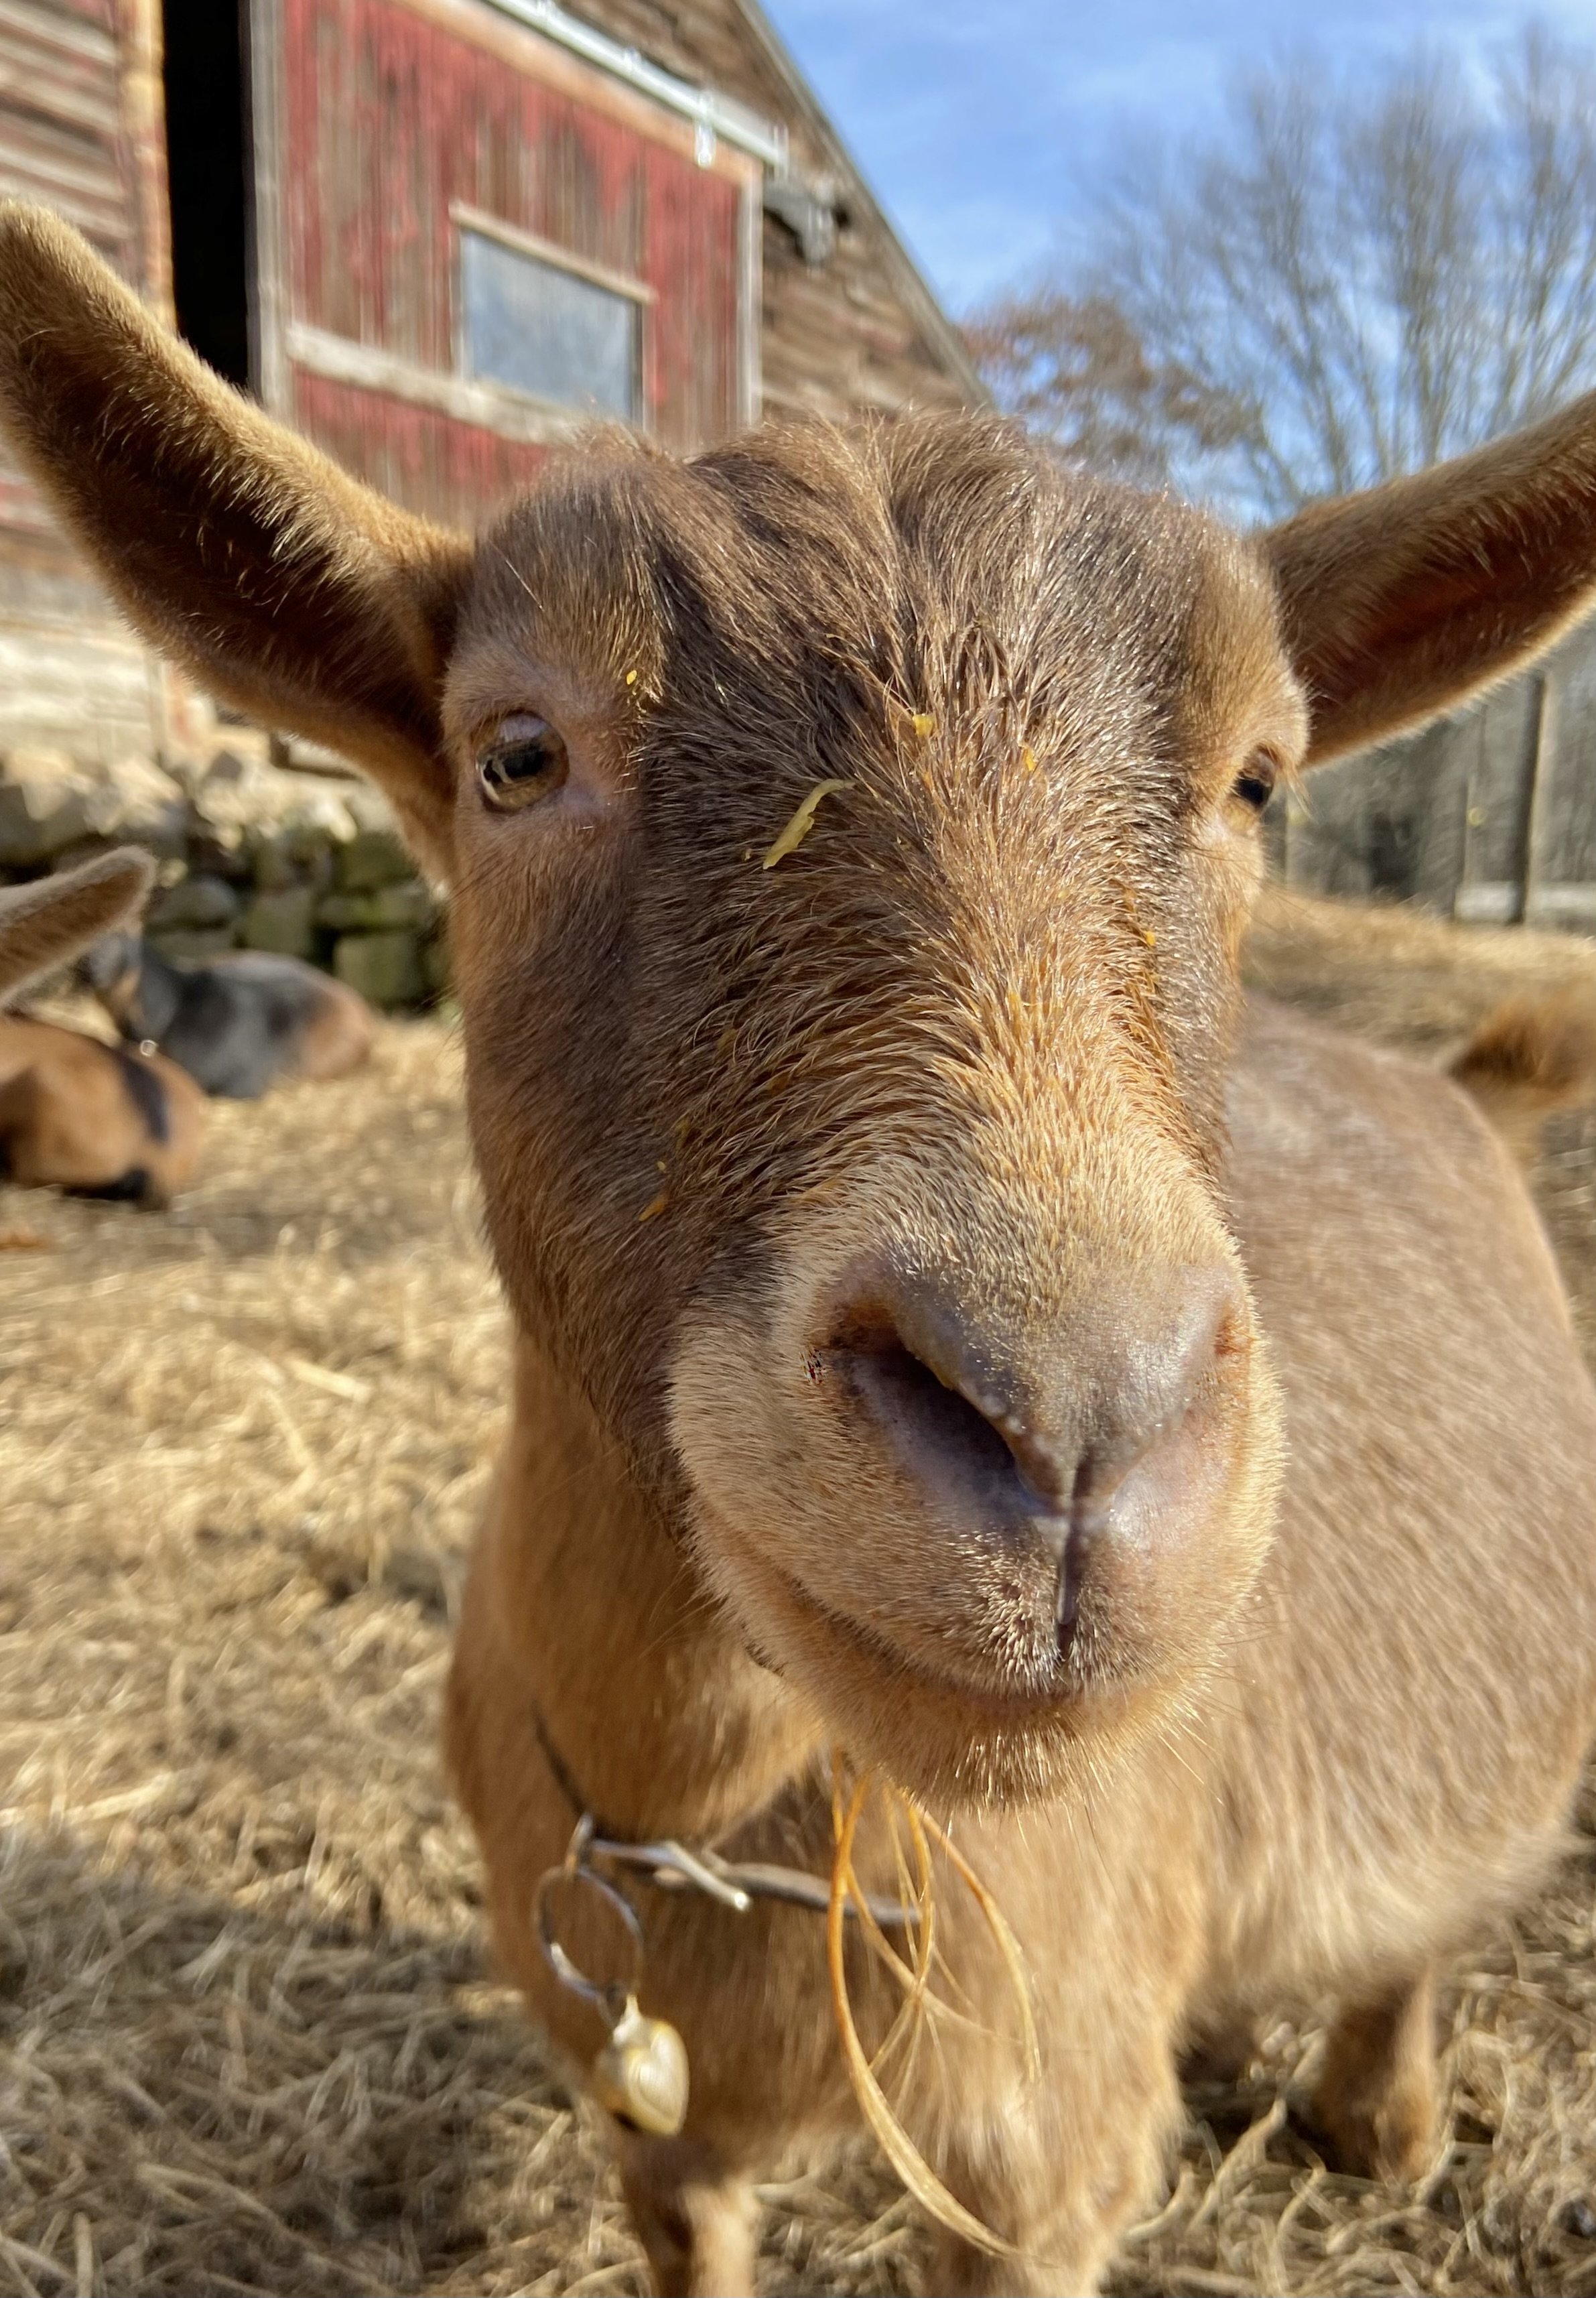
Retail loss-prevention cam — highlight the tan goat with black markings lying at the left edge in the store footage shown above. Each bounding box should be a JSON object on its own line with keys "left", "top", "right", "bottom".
{"left": 0, "top": 848, "right": 204, "bottom": 1204}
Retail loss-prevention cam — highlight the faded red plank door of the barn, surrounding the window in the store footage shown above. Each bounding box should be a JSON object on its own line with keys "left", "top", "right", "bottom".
{"left": 271, "top": 0, "right": 753, "bottom": 521}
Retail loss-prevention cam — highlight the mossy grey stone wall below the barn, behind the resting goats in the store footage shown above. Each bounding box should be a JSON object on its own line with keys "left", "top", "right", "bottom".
{"left": 0, "top": 726, "right": 448, "bottom": 1007}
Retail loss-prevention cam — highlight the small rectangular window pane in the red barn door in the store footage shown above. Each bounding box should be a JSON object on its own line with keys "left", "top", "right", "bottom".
{"left": 459, "top": 227, "right": 643, "bottom": 423}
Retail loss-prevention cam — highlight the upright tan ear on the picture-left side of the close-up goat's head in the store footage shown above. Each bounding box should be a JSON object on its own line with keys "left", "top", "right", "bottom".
{"left": 0, "top": 202, "right": 471, "bottom": 873}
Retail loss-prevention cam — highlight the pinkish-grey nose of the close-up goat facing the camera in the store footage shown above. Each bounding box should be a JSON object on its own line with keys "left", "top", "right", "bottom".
{"left": 817, "top": 1266, "right": 1247, "bottom": 1648}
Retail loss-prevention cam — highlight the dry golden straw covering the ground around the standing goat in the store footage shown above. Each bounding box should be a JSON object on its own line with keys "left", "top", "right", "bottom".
{"left": 0, "top": 919, "right": 1596, "bottom": 2298}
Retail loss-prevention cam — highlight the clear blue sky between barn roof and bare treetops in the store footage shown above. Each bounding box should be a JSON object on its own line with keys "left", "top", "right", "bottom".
{"left": 767, "top": 0, "right": 1596, "bottom": 312}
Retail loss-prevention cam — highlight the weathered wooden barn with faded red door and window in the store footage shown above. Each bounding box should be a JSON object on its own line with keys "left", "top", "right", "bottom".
{"left": 0, "top": 0, "right": 983, "bottom": 759}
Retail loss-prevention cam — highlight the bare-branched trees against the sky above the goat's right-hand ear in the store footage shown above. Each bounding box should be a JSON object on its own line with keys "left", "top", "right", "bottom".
{"left": 972, "top": 27, "right": 1596, "bottom": 515}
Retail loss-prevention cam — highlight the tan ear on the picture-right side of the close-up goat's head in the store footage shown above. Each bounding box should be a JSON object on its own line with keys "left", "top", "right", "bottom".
{"left": 1261, "top": 393, "right": 1596, "bottom": 765}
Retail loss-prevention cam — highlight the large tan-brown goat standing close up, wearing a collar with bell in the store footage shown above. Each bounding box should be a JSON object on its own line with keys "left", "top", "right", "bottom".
{"left": 0, "top": 209, "right": 1596, "bottom": 2293}
